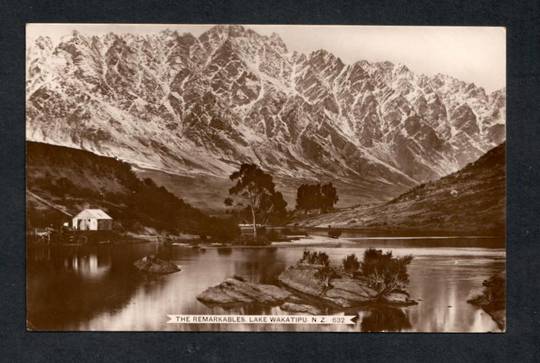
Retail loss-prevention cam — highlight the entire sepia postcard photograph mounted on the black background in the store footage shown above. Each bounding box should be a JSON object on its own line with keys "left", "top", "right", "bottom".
{"left": 25, "top": 23, "right": 507, "bottom": 333}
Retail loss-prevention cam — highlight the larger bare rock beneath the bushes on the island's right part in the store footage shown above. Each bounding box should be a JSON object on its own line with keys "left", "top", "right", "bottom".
{"left": 279, "top": 264, "right": 416, "bottom": 308}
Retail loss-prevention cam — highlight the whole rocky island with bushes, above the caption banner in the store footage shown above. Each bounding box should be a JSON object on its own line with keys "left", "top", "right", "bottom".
{"left": 197, "top": 249, "right": 416, "bottom": 314}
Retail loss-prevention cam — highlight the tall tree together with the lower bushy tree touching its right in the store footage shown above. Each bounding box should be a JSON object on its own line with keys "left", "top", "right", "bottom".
{"left": 224, "top": 164, "right": 287, "bottom": 240}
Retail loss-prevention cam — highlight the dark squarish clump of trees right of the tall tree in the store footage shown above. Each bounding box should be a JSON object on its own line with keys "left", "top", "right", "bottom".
{"left": 296, "top": 183, "right": 339, "bottom": 212}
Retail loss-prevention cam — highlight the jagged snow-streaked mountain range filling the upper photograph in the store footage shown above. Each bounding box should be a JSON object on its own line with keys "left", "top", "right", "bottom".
{"left": 26, "top": 25, "right": 506, "bottom": 201}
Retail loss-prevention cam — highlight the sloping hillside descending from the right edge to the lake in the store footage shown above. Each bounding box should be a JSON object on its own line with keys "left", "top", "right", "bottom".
{"left": 299, "top": 143, "right": 506, "bottom": 235}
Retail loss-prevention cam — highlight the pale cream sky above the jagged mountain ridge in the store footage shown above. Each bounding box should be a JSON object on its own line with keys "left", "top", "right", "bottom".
{"left": 27, "top": 24, "right": 506, "bottom": 92}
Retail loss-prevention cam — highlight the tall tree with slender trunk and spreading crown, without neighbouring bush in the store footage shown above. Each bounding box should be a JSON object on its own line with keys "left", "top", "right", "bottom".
{"left": 229, "top": 164, "right": 280, "bottom": 240}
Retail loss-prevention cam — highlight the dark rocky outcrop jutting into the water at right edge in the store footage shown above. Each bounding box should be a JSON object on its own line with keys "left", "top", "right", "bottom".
{"left": 467, "top": 271, "right": 506, "bottom": 330}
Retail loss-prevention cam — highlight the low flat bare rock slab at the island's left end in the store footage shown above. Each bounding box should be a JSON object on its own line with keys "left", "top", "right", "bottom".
{"left": 197, "top": 277, "right": 291, "bottom": 305}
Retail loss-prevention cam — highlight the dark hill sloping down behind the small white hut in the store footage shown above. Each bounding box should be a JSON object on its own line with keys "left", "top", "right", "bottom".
{"left": 26, "top": 142, "right": 231, "bottom": 233}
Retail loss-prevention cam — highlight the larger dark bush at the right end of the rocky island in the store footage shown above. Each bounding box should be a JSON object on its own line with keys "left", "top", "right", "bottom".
{"left": 361, "top": 248, "right": 413, "bottom": 296}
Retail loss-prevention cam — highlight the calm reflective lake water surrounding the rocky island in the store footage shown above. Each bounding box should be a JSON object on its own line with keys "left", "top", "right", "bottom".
{"left": 27, "top": 233, "right": 506, "bottom": 332}
